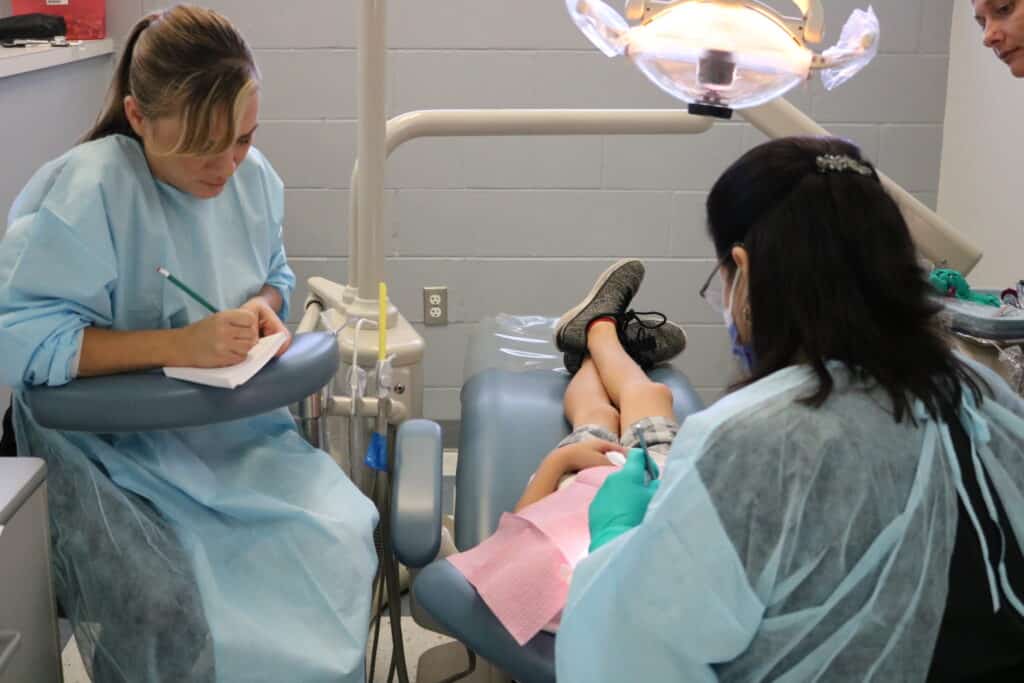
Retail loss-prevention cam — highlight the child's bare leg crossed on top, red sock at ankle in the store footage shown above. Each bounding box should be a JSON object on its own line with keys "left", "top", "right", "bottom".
{"left": 587, "top": 319, "right": 675, "bottom": 434}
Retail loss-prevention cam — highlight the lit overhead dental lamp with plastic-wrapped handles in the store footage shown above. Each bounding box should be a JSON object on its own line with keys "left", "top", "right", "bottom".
{"left": 565, "top": 0, "right": 879, "bottom": 118}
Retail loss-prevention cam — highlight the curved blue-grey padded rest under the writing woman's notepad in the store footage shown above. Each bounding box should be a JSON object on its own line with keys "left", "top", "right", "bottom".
{"left": 25, "top": 332, "right": 341, "bottom": 433}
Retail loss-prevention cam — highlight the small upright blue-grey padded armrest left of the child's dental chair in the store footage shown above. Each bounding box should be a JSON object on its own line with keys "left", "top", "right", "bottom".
{"left": 391, "top": 420, "right": 442, "bottom": 568}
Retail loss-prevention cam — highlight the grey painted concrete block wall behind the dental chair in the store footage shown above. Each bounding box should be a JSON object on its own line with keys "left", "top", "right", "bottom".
{"left": 0, "top": 0, "right": 953, "bottom": 428}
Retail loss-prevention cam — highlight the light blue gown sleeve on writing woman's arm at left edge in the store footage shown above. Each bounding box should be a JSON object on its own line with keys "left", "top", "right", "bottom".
{"left": 0, "top": 156, "right": 118, "bottom": 386}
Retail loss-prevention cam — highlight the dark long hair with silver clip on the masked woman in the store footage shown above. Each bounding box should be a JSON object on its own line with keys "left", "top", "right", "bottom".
{"left": 708, "top": 138, "right": 983, "bottom": 421}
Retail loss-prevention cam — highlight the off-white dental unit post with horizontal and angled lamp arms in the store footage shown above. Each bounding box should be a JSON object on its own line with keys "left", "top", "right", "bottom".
{"left": 298, "top": 0, "right": 981, "bottom": 679}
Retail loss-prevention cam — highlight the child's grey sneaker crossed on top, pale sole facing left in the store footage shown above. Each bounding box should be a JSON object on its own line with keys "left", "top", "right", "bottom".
{"left": 555, "top": 258, "right": 644, "bottom": 352}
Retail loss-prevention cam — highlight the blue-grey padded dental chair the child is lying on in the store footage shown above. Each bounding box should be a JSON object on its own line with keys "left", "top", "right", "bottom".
{"left": 391, "top": 316, "right": 702, "bottom": 683}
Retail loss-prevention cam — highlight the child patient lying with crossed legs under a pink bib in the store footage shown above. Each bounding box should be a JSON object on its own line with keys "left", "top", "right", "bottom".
{"left": 447, "top": 259, "right": 686, "bottom": 644}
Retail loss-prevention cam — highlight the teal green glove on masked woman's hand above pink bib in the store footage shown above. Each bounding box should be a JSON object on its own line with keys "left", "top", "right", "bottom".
{"left": 589, "top": 449, "right": 660, "bottom": 552}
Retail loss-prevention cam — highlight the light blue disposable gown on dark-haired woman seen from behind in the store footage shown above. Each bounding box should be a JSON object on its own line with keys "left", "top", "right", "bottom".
{"left": 556, "top": 365, "right": 1024, "bottom": 683}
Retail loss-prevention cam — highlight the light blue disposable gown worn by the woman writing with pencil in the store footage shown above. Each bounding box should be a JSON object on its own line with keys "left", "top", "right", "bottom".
{"left": 0, "top": 136, "right": 377, "bottom": 683}
